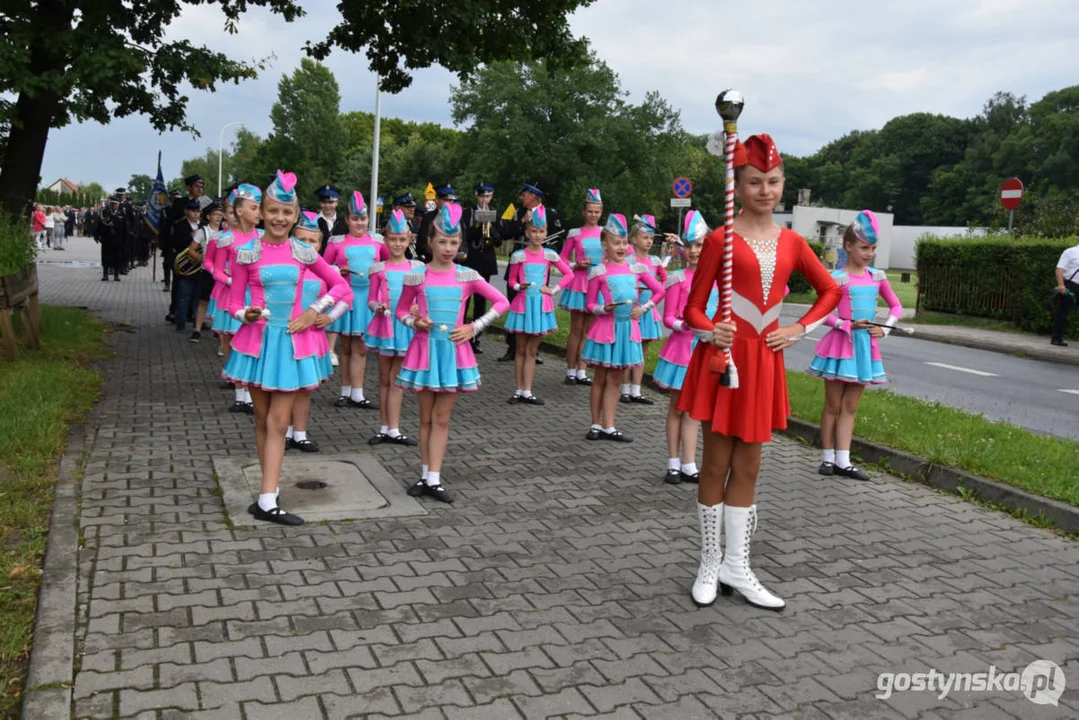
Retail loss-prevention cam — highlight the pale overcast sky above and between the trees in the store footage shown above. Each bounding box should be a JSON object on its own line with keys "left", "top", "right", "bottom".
{"left": 41, "top": 0, "right": 1079, "bottom": 192}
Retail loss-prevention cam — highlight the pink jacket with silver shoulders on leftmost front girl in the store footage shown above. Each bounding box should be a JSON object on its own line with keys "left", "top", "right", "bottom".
{"left": 229, "top": 236, "right": 353, "bottom": 358}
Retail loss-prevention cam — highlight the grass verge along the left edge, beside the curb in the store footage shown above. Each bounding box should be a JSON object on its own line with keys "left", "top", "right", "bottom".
{"left": 0, "top": 305, "right": 105, "bottom": 718}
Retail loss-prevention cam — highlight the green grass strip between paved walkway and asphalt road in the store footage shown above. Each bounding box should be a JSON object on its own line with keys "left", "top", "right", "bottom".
{"left": 498, "top": 310, "right": 1079, "bottom": 506}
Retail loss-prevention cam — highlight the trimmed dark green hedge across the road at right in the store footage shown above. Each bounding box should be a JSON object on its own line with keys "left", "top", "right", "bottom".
{"left": 917, "top": 235, "right": 1079, "bottom": 337}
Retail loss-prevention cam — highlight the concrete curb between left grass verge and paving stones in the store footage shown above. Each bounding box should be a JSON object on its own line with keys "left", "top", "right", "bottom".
{"left": 22, "top": 422, "right": 91, "bottom": 720}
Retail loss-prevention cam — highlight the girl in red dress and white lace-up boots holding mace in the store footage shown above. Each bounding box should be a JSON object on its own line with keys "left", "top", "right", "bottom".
{"left": 678, "top": 135, "right": 841, "bottom": 610}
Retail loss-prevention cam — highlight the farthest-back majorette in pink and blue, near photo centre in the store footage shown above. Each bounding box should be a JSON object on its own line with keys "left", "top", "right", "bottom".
{"left": 558, "top": 188, "right": 603, "bottom": 385}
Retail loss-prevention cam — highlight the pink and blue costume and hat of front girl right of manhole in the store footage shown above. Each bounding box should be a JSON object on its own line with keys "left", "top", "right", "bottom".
{"left": 397, "top": 203, "right": 509, "bottom": 393}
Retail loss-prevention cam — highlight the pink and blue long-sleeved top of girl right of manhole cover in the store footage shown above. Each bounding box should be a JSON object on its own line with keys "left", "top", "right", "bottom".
{"left": 397, "top": 266, "right": 509, "bottom": 367}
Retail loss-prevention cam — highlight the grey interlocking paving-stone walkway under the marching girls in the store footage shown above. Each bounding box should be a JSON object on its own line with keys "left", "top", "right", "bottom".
{"left": 23, "top": 241, "right": 1079, "bottom": 720}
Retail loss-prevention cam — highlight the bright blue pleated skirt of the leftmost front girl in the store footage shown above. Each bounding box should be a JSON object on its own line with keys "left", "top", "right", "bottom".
{"left": 221, "top": 324, "right": 333, "bottom": 392}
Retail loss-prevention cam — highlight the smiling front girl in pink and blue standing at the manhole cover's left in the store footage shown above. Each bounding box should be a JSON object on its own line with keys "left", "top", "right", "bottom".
{"left": 223, "top": 171, "right": 353, "bottom": 525}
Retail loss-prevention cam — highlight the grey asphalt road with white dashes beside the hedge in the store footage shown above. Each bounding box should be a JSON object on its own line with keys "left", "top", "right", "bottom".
{"left": 492, "top": 264, "right": 1079, "bottom": 440}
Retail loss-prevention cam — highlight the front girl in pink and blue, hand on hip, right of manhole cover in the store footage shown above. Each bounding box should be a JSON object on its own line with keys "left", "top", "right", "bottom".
{"left": 397, "top": 203, "right": 509, "bottom": 503}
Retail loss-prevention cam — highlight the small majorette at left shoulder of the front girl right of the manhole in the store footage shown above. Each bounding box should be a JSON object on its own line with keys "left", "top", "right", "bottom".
{"left": 364, "top": 209, "right": 426, "bottom": 446}
